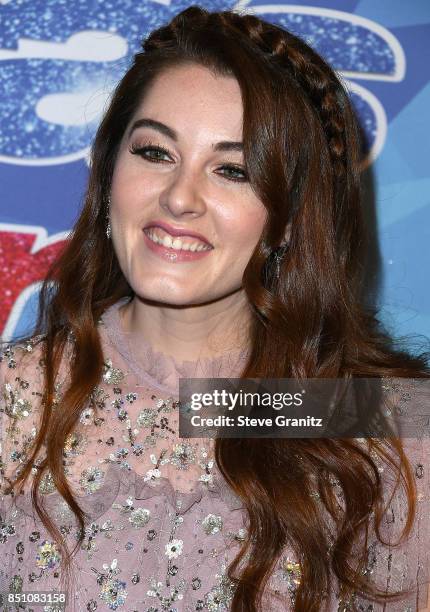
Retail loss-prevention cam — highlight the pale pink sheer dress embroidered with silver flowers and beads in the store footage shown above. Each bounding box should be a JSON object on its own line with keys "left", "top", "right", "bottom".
{"left": 0, "top": 298, "right": 430, "bottom": 612}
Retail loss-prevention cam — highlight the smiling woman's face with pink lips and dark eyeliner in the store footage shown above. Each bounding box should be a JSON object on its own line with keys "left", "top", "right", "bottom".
{"left": 111, "top": 64, "right": 267, "bottom": 305}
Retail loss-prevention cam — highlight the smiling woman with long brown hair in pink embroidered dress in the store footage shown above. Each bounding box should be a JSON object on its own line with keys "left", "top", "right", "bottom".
{"left": 0, "top": 7, "right": 429, "bottom": 612}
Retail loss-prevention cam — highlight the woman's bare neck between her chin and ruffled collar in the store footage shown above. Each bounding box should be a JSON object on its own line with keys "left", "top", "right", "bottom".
{"left": 119, "top": 290, "right": 250, "bottom": 362}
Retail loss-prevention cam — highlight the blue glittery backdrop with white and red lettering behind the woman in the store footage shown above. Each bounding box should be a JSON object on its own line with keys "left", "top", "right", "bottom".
{"left": 0, "top": 0, "right": 430, "bottom": 339}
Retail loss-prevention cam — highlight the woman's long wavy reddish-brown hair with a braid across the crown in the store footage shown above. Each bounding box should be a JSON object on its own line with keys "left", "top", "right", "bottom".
{"left": 3, "top": 6, "right": 430, "bottom": 612}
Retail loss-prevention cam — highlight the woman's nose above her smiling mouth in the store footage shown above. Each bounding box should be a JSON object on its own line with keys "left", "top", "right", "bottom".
{"left": 159, "top": 166, "right": 206, "bottom": 217}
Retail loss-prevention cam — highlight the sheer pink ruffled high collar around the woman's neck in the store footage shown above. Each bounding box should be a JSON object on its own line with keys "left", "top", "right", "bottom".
{"left": 100, "top": 296, "right": 248, "bottom": 394}
